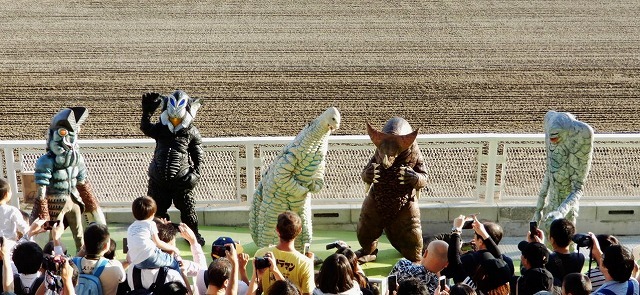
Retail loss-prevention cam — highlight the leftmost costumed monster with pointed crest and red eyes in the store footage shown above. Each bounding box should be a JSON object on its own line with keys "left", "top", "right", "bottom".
{"left": 30, "top": 107, "right": 106, "bottom": 249}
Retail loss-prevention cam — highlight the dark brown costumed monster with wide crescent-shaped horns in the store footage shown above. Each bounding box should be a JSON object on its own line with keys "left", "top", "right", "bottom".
{"left": 356, "top": 117, "right": 427, "bottom": 262}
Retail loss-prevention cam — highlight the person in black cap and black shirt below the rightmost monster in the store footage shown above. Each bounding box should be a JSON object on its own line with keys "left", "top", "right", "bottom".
{"left": 516, "top": 240, "right": 553, "bottom": 295}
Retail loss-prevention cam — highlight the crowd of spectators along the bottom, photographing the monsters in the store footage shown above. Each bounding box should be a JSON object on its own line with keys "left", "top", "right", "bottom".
{"left": 0, "top": 177, "right": 640, "bottom": 295}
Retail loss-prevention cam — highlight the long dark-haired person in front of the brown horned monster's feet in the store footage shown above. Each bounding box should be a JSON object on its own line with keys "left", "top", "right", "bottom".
{"left": 313, "top": 253, "right": 362, "bottom": 295}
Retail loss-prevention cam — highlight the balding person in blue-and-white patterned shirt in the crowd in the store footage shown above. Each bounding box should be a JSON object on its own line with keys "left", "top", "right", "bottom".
{"left": 389, "top": 240, "right": 449, "bottom": 294}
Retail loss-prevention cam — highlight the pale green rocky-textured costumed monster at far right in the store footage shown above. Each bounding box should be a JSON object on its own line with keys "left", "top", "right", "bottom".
{"left": 533, "top": 111, "right": 593, "bottom": 233}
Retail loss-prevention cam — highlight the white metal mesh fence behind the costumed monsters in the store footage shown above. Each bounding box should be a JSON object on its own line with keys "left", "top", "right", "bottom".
{"left": 0, "top": 134, "right": 640, "bottom": 208}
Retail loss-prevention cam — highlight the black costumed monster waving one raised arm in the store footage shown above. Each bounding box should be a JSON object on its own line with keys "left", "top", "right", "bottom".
{"left": 140, "top": 90, "right": 205, "bottom": 245}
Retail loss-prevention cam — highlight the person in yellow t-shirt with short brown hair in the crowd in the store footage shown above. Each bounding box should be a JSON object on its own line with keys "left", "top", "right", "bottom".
{"left": 254, "top": 211, "right": 315, "bottom": 294}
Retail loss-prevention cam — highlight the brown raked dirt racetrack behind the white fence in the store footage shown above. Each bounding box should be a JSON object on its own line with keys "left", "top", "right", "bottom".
{"left": 0, "top": 0, "right": 640, "bottom": 139}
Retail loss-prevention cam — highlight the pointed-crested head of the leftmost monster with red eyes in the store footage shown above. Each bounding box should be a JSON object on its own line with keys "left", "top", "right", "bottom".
{"left": 47, "top": 107, "right": 89, "bottom": 166}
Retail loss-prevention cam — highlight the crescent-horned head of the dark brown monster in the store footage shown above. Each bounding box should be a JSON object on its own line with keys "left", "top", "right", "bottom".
{"left": 367, "top": 117, "right": 418, "bottom": 169}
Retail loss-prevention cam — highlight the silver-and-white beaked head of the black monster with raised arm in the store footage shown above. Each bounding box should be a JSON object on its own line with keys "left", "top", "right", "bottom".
{"left": 160, "top": 90, "right": 201, "bottom": 133}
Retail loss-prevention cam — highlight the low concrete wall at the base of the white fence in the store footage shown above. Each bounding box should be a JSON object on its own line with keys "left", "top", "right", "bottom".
{"left": 105, "top": 201, "right": 640, "bottom": 236}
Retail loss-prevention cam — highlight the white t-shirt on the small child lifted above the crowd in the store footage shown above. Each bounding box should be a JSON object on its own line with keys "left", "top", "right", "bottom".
{"left": 127, "top": 220, "right": 158, "bottom": 265}
